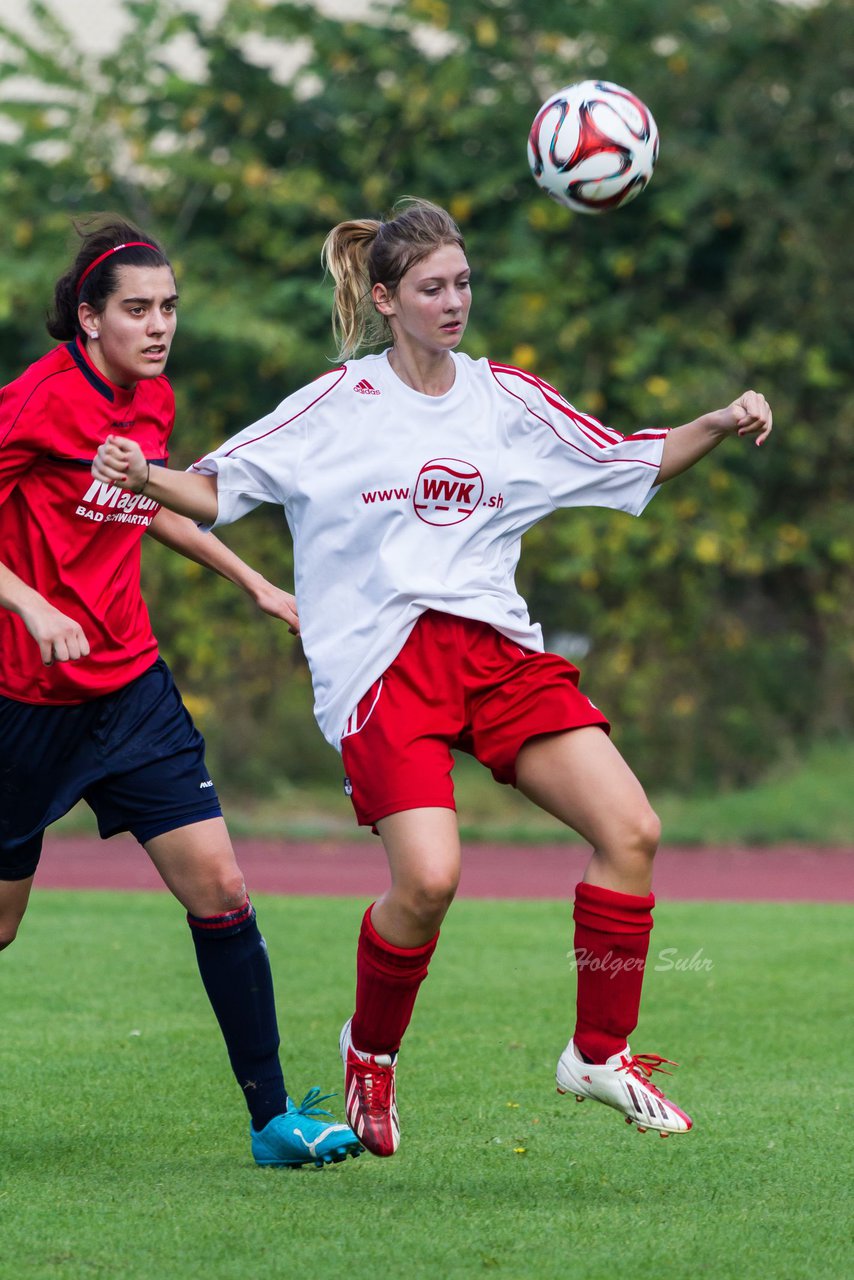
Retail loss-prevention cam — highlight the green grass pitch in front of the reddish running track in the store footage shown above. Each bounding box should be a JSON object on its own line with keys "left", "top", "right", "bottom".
{"left": 0, "top": 891, "right": 854, "bottom": 1280}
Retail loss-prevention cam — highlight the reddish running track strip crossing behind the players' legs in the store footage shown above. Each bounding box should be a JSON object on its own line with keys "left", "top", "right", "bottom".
{"left": 36, "top": 836, "right": 854, "bottom": 902}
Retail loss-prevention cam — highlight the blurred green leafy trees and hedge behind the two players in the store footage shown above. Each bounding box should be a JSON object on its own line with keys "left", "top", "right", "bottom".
{"left": 0, "top": 0, "right": 854, "bottom": 788}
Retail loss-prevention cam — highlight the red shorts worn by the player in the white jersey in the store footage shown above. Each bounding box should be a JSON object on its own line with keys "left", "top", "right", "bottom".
{"left": 341, "top": 611, "right": 609, "bottom": 827}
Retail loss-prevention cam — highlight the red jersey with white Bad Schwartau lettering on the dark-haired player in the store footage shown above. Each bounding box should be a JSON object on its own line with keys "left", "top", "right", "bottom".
{"left": 0, "top": 342, "right": 174, "bottom": 705}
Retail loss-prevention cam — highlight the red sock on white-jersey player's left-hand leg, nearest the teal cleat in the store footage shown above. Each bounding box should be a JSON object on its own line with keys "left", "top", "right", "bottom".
{"left": 351, "top": 906, "right": 439, "bottom": 1053}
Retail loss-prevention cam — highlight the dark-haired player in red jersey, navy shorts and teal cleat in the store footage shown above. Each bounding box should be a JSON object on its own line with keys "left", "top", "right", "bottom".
{"left": 0, "top": 216, "right": 361, "bottom": 1166}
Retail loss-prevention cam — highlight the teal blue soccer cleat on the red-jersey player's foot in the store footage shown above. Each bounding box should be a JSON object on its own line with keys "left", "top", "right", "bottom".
{"left": 250, "top": 1085, "right": 365, "bottom": 1169}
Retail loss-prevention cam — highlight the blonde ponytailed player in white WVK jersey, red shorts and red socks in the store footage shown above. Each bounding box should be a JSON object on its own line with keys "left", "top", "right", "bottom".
{"left": 93, "top": 201, "right": 771, "bottom": 1156}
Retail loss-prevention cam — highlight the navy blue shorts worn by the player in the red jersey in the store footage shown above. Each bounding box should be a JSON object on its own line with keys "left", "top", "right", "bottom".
{"left": 0, "top": 658, "right": 222, "bottom": 879}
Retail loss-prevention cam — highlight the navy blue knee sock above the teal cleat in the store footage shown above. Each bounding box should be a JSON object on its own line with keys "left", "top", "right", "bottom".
{"left": 187, "top": 899, "right": 288, "bottom": 1129}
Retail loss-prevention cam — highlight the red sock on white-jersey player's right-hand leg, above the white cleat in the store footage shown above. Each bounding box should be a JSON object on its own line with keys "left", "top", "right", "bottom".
{"left": 572, "top": 882, "right": 656, "bottom": 1062}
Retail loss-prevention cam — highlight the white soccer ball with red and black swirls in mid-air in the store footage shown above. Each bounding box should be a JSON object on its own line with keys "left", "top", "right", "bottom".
{"left": 528, "top": 81, "right": 658, "bottom": 214}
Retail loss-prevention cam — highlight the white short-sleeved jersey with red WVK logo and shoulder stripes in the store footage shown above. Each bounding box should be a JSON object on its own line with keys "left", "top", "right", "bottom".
{"left": 195, "top": 352, "right": 667, "bottom": 748}
